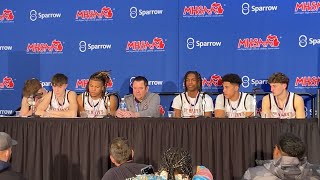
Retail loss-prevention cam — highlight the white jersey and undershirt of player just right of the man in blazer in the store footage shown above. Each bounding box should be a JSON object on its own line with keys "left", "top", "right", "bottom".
{"left": 171, "top": 92, "right": 214, "bottom": 118}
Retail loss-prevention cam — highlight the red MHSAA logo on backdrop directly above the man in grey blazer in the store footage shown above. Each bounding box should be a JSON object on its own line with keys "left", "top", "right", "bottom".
{"left": 126, "top": 37, "right": 166, "bottom": 52}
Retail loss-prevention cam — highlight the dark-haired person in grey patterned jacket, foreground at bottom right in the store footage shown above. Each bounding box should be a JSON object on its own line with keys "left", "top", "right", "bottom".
{"left": 243, "top": 133, "right": 320, "bottom": 180}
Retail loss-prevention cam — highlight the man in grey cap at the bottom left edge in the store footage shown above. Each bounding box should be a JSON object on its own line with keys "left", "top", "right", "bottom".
{"left": 0, "top": 132, "right": 23, "bottom": 180}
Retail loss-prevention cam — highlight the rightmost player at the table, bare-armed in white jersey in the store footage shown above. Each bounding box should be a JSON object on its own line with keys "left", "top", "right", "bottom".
{"left": 261, "top": 72, "right": 305, "bottom": 119}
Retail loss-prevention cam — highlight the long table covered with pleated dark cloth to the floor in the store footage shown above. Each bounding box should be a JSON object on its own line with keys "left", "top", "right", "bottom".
{"left": 0, "top": 117, "right": 320, "bottom": 180}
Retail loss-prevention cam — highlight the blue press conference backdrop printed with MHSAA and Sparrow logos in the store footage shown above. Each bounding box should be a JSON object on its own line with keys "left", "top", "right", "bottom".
{"left": 0, "top": 0, "right": 320, "bottom": 115}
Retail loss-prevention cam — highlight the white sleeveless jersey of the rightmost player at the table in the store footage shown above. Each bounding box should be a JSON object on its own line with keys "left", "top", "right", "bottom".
{"left": 269, "top": 92, "right": 296, "bottom": 119}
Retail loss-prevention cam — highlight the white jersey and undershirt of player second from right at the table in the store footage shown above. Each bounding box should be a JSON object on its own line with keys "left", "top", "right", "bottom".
{"left": 215, "top": 92, "right": 254, "bottom": 118}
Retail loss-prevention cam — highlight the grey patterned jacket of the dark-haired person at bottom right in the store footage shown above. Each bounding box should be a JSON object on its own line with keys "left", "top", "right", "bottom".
{"left": 243, "top": 156, "right": 320, "bottom": 180}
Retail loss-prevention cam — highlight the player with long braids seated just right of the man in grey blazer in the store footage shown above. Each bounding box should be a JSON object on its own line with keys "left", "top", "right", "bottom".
{"left": 172, "top": 71, "right": 213, "bottom": 118}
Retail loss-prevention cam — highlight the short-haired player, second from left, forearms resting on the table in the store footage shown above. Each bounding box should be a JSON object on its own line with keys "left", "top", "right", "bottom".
{"left": 36, "top": 73, "right": 78, "bottom": 117}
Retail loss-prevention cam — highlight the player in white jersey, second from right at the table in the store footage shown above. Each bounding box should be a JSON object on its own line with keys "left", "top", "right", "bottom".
{"left": 214, "top": 74, "right": 254, "bottom": 118}
